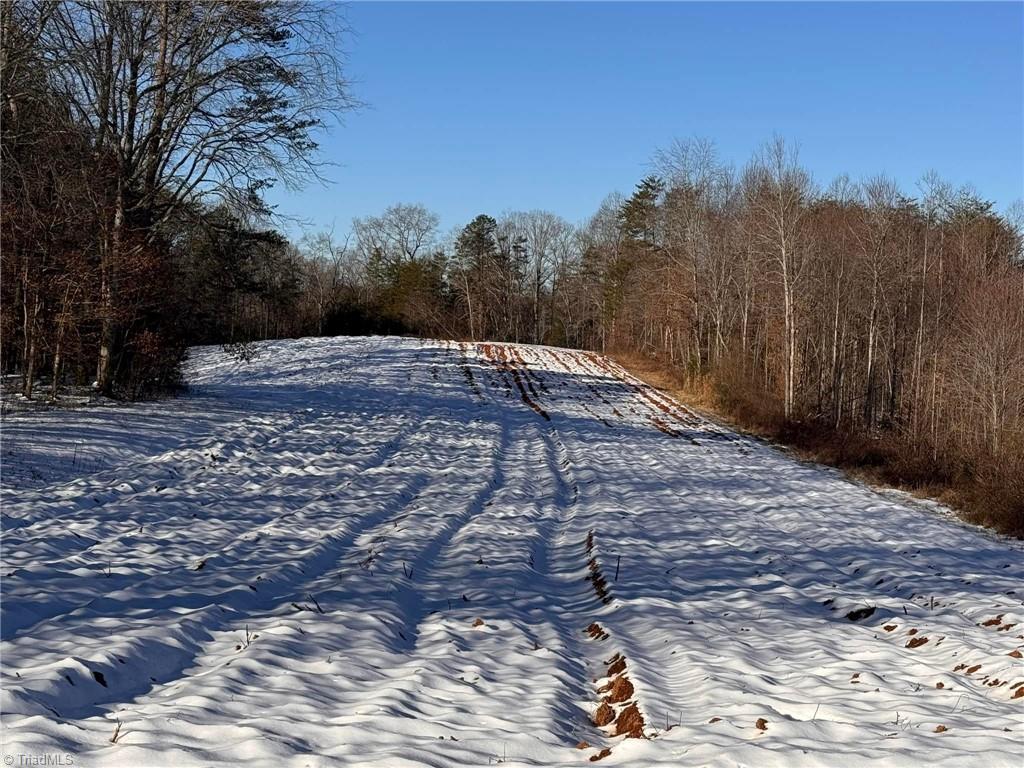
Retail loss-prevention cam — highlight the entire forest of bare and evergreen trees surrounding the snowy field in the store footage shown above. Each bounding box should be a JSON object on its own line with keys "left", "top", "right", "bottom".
{"left": 0, "top": 2, "right": 1024, "bottom": 535}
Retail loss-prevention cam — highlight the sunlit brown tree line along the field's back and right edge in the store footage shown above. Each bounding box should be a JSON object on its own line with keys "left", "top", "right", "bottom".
{"left": 251, "top": 138, "right": 1024, "bottom": 534}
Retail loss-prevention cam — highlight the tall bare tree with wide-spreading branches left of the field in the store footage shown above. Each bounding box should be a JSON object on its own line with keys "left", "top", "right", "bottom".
{"left": 41, "top": 0, "right": 354, "bottom": 389}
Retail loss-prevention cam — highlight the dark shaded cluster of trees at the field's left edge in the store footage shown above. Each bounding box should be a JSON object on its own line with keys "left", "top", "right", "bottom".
{"left": 0, "top": 0, "right": 354, "bottom": 398}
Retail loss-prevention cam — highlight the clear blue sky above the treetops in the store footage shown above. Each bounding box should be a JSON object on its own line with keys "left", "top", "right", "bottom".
{"left": 269, "top": 2, "right": 1024, "bottom": 233}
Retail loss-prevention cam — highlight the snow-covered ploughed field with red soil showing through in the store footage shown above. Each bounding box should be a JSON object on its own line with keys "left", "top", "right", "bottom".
{"left": 0, "top": 338, "right": 1024, "bottom": 768}
